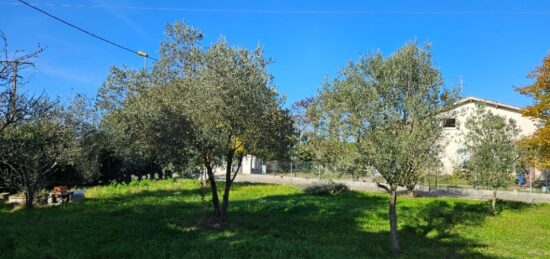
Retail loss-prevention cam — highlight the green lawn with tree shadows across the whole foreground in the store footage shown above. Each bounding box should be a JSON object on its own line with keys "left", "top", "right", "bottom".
{"left": 0, "top": 180, "right": 550, "bottom": 258}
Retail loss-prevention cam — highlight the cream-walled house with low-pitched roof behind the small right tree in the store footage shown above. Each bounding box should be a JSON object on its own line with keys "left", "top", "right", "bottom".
{"left": 441, "top": 97, "right": 540, "bottom": 176}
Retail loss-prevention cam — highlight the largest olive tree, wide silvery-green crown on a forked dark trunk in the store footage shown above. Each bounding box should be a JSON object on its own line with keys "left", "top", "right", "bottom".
{"left": 98, "top": 23, "right": 294, "bottom": 226}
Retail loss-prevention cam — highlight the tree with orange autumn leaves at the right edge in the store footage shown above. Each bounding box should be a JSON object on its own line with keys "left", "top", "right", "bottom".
{"left": 517, "top": 54, "right": 550, "bottom": 168}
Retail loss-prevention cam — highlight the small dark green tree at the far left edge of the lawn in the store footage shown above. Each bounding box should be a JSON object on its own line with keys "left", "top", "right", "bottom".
{"left": 0, "top": 100, "right": 75, "bottom": 208}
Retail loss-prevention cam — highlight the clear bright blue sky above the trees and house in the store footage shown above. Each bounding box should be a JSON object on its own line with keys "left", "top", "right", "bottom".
{"left": 0, "top": 0, "right": 550, "bottom": 106}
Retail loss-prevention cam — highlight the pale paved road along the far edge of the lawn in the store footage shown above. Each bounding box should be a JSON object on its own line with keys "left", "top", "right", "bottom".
{"left": 235, "top": 174, "right": 550, "bottom": 203}
